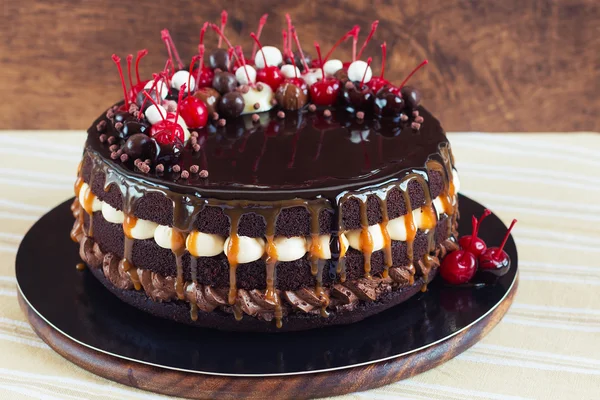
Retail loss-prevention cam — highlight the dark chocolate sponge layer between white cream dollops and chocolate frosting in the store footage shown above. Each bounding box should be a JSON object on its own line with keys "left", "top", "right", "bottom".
{"left": 84, "top": 212, "right": 449, "bottom": 290}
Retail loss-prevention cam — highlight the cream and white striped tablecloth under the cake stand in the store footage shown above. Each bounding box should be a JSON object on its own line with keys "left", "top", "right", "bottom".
{"left": 0, "top": 132, "right": 600, "bottom": 399}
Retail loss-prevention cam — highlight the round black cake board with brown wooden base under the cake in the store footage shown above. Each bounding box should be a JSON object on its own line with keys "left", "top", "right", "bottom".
{"left": 16, "top": 196, "right": 518, "bottom": 399}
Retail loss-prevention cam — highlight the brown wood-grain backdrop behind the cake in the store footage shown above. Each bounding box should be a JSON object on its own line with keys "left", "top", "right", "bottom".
{"left": 0, "top": 0, "right": 600, "bottom": 131}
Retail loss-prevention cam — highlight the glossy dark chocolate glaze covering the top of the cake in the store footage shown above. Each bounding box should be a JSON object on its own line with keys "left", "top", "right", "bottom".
{"left": 86, "top": 107, "right": 447, "bottom": 200}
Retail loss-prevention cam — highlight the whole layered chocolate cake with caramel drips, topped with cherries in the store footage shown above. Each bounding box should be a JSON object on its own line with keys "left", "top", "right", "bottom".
{"left": 71, "top": 13, "right": 459, "bottom": 331}
